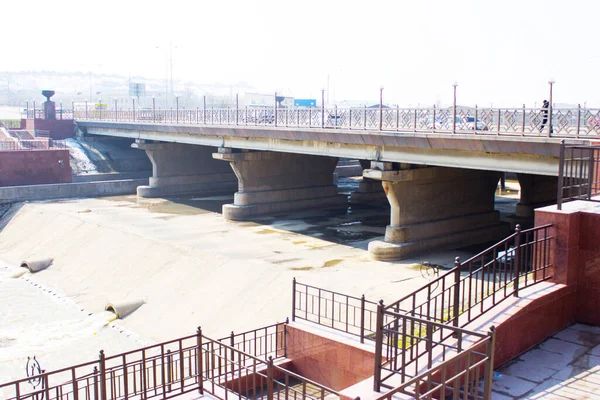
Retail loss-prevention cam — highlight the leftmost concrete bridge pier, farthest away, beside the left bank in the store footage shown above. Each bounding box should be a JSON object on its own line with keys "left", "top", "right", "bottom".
{"left": 131, "top": 142, "right": 237, "bottom": 197}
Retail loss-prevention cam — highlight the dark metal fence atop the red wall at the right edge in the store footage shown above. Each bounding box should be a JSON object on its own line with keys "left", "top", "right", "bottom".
{"left": 556, "top": 140, "right": 600, "bottom": 210}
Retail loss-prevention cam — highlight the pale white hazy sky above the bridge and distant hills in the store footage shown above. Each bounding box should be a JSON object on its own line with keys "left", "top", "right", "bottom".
{"left": 0, "top": 0, "right": 600, "bottom": 107}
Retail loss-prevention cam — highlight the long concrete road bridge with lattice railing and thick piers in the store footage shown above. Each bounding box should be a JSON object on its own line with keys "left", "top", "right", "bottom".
{"left": 73, "top": 105, "right": 600, "bottom": 260}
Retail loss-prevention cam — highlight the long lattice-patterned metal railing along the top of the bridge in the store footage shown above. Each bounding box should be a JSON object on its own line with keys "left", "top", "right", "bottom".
{"left": 71, "top": 107, "right": 600, "bottom": 138}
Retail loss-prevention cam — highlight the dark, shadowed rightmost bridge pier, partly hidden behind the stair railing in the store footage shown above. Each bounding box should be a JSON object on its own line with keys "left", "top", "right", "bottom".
{"left": 516, "top": 174, "right": 558, "bottom": 220}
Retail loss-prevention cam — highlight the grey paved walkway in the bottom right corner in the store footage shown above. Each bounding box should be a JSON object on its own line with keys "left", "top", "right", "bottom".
{"left": 492, "top": 324, "right": 600, "bottom": 400}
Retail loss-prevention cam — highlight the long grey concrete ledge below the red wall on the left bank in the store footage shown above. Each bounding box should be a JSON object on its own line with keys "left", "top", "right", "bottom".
{"left": 0, "top": 179, "right": 148, "bottom": 203}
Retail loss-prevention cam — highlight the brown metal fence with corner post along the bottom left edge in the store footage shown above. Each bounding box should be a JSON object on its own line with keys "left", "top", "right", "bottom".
{"left": 0, "top": 324, "right": 346, "bottom": 400}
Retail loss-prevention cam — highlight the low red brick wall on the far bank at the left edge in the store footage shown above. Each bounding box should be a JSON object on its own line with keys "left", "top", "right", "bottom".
{"left": 0, "top": 150, "right": 71, "bottom": 186}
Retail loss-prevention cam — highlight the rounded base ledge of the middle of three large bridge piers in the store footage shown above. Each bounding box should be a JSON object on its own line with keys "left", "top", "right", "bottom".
{"left": 223, "top": 194, "right": 348, "bottom": 221}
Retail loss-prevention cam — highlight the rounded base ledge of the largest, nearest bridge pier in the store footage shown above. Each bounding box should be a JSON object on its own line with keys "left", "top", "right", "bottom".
{"left": 369, "top": 224, "right": 508, "bottom": 261}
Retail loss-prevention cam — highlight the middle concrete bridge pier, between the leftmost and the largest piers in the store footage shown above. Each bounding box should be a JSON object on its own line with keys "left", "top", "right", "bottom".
{"left": 213, "top": 149, "right": 348, "bottom": 220}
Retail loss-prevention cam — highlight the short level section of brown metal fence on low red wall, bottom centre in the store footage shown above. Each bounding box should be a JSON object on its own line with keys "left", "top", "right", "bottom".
{"left": 292, "top": 278, "right": 377, "bottom": 343}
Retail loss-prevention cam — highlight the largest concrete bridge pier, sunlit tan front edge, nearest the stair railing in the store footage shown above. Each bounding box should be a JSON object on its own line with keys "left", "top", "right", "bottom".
{"left": 363, "top": 163, "right": 509, "bottom": 260}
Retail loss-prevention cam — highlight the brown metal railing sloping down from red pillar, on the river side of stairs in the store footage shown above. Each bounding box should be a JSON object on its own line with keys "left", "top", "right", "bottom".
{"left": 374, "top": 224, "right": 552, "bottom": 391}
